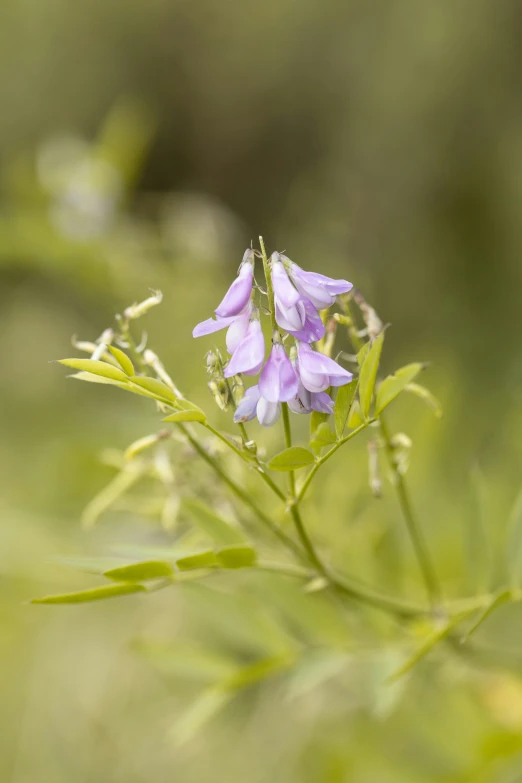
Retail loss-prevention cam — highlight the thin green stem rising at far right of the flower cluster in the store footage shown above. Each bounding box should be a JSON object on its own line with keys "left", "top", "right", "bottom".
{"left": 380, "top": 417, "right": 440, "bottom": 608}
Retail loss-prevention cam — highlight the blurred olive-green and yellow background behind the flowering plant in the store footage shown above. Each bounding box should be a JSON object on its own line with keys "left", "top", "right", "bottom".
{"left": 0, "top": 0, "right": 522, "bottom": 783}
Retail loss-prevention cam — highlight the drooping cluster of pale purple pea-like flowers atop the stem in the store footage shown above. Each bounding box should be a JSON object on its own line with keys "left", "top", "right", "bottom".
{"left": 193, "top": 249, "right": 352, "bottom": 427}
